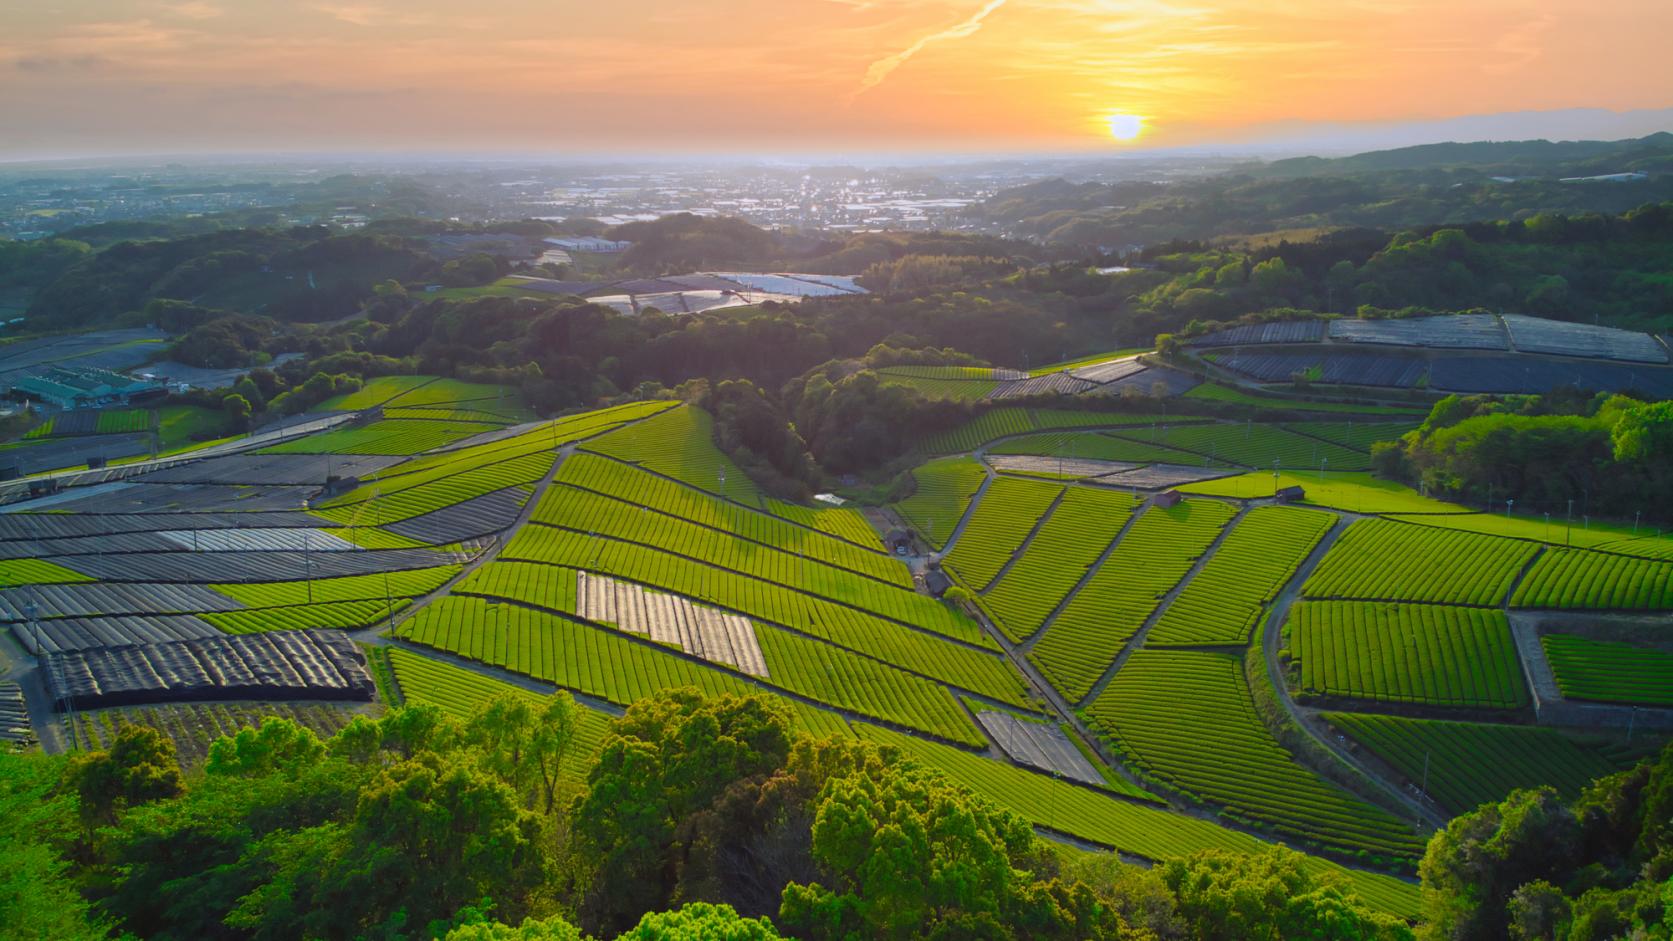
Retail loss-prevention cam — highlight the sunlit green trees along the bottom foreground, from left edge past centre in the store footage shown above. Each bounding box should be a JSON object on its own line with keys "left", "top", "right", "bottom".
{"left": 0, "top": 679, "right": 1412, "bottom": 941}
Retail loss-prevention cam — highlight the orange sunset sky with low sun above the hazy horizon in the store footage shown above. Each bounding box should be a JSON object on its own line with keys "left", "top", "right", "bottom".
{"left": 0, "top": 0, "right": 1673, "bottom": 156}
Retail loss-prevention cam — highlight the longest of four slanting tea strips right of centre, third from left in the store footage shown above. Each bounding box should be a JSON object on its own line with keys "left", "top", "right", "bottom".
{"left": 1029, "top": 501, "right": 1236, "bottom": 702}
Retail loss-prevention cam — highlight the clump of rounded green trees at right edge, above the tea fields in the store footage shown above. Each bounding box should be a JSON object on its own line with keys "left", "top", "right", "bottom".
{"left": 1372, "top": 388, "right": 1673, "bottom": 524}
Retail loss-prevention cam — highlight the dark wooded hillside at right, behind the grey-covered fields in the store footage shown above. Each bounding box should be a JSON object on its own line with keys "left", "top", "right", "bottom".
{"left": 1021, "top": 203, "right": 1673, "bottom": 333}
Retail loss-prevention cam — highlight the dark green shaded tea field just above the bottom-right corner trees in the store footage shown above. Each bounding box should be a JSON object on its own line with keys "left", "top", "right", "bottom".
{"left": 1325, "top": 712, "right": 1616, "bottom": 814}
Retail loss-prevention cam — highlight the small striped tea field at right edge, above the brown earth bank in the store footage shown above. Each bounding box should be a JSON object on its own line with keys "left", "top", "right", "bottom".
{"left": 1511, "top": 549, "right": 1673, "bottom": 611}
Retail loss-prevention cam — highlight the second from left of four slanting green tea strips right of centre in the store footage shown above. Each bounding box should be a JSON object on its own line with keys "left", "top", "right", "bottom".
{"left": 982, "top": 487, "right": 1136, "bottom": 641}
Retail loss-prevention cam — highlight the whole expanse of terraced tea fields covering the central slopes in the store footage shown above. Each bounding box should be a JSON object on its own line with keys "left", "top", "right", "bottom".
{"left": 0, "top": 378, "right": 1673, "bottom": 916}
